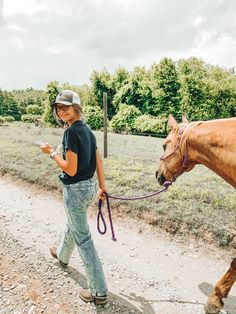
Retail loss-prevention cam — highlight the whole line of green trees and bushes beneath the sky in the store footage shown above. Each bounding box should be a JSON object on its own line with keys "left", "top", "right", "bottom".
{"left": 0, "top": 57, "right": 236, "bottom": 134}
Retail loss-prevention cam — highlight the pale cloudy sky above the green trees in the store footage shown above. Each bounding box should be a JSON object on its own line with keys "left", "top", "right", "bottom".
{"left": 0, "top": 0, "right": 236, "bottom": 90}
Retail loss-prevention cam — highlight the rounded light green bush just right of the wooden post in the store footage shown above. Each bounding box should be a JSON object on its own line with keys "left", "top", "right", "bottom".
{"left": 111, "top": 104, "right": 141, "bottom": 132}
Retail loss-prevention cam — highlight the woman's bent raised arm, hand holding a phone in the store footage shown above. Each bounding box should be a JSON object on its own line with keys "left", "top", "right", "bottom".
{"left": 40, "top": 144, "right": 78, "bottom": 177}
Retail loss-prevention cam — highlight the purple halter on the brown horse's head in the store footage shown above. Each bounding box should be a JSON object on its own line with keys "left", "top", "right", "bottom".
{"left": 160, "top": 127, "right": 188, "bottom": 182}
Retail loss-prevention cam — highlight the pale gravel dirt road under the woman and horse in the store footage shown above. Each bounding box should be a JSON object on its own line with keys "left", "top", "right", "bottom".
{"left": 0, "top": 177, "right": 236, "bottom": 314}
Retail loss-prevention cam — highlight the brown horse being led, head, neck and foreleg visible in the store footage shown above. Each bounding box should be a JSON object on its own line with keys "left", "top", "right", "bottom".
{"left": 156, "top": 116, "right": 236, "bottom": 313}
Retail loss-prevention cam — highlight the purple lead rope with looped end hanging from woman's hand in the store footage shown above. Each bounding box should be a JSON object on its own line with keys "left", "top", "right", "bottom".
{"left": 97, "top": 181, "right": 172, "bottom": 241}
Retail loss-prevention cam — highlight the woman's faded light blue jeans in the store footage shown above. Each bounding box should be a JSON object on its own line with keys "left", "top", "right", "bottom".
{"left": 57, "top": 179, "right": 107, "bottom": 296}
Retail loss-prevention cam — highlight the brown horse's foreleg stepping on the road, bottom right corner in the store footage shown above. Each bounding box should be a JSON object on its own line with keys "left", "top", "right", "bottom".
{"left": 205, "top": 258, "right": 236, "bottom": 314}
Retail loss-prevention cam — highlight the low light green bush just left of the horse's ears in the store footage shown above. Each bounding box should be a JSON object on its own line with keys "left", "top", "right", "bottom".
{"left": 134, "top": 115, "right": 167, "bottom": 134}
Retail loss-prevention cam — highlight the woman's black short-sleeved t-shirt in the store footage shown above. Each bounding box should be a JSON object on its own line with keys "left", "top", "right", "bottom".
{"left": 59, "top": 120, "right": 96, "bottom": 185}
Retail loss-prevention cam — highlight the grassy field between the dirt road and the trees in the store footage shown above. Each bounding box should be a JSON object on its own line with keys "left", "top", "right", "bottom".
{"left": 0, "top": 123, "right": 236, "bottom": 248}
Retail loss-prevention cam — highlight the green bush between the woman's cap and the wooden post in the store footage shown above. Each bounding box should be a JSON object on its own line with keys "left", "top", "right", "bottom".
{"left": 84, "top": 106, "right": 103, "bottom": 130}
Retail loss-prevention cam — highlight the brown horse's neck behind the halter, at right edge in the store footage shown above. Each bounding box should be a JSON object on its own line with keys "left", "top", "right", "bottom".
{"left": 187, "top": 118, "right": 236, "bottom": 188}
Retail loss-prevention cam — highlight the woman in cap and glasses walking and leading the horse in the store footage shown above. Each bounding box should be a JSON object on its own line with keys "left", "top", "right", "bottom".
{"left": 40, "top": 90, "right": 108, "bottom": 304}
